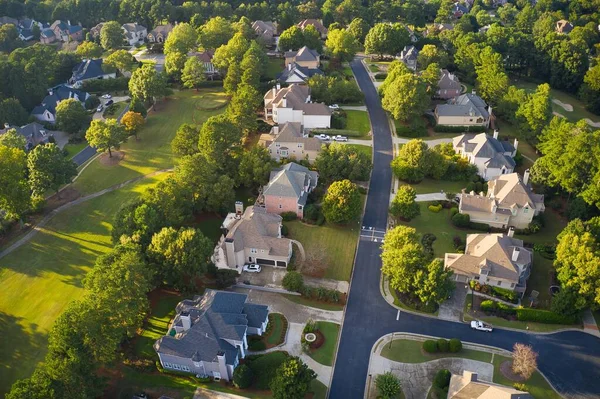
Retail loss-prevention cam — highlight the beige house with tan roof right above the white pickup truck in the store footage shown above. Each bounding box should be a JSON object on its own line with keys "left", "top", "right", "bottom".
{"left": 444, "top": 233, "right": 533, "bottom": 295}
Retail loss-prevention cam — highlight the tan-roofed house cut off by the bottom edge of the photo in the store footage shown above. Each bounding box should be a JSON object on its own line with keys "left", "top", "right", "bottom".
{"left": 447, "top": 370, "right": 533, "bottom": 399}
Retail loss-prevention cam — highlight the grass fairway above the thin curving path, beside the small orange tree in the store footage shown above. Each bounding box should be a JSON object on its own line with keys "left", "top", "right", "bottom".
{"left": 73, "top": 88, "right": 227, "bottom": 194}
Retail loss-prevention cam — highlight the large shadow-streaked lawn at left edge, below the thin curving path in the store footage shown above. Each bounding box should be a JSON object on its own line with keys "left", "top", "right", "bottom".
{"left": 0, "top": 175, "right": 164, "bottom": 395}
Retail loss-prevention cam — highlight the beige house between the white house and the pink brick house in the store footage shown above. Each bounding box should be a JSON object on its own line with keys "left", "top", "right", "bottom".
{"left": 264, "top": 122, "right": 322, "bottom": 162}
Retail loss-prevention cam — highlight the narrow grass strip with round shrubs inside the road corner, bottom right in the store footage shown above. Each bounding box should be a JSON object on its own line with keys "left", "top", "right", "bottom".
{"left": 381, "top": 339, "right": 492, "bottom": 363}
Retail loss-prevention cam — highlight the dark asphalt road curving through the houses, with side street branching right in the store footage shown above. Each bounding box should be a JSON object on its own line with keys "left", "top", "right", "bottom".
{"left": 329, "top": 60, "right": 600, "bottom": 399}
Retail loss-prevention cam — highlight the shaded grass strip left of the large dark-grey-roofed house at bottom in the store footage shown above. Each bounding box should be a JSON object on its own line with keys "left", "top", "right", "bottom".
{"left": 134, "top": 292, "right": 184, "bottom": 360}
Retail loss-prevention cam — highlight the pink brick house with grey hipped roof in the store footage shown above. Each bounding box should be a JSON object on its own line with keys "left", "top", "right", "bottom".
{"left": 258, "top": 162, "right": 319, "bottom": 218}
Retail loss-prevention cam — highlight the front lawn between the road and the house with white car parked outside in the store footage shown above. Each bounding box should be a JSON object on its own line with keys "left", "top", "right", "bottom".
{"left": 285, "top": 220, "right": 359, "bottom": 281}
